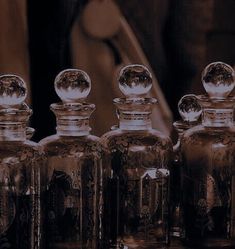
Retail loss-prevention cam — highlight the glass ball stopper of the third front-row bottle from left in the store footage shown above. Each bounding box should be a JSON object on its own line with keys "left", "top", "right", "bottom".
{"left": 118, "top": 64, "right": 152, "bottom": 97}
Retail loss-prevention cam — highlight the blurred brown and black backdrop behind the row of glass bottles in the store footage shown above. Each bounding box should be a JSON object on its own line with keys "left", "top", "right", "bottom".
{"left": 0, "top": 0, "right": 235, "bottom": 141}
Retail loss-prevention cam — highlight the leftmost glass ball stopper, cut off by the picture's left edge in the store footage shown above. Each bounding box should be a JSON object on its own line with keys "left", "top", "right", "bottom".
{"left": 0, "top": 74, "right": 27, "bottom": 107}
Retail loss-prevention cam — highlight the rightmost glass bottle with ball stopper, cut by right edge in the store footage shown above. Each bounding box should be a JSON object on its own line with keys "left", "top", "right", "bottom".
{"left": 181, "top": 62, "right": 235, "bottom": 248}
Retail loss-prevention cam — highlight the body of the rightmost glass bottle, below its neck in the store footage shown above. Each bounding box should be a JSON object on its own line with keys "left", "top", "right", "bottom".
{"left": 181, "top": 126, "right": 235, "bottom": 248}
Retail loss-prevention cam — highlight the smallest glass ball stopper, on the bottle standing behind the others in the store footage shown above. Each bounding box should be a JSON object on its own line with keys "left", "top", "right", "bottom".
{"left": 178, "top": 94, "right": 202, "bottom": 122}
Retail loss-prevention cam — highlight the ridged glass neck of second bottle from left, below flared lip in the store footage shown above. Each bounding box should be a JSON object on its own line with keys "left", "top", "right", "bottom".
{"left": 56, "top": 117, "right": 91, "bottom": 136}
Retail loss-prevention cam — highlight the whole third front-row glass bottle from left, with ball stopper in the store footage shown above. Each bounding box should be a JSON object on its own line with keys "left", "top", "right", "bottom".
{"left": 101, "top": 65, "right": 172, "bottom": 249}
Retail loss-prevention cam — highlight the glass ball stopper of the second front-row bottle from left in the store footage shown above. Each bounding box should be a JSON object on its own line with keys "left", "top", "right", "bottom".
{"left": 55, "top": 69, "right": 91, "bottom": 103}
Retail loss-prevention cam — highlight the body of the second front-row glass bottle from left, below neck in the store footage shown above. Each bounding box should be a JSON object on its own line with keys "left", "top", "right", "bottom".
{"left": 41, "top": 135, "right": 102, "bottom": 249}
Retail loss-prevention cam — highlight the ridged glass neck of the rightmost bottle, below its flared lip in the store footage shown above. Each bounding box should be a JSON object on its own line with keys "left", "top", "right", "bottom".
{"left": 202, "top": 108, "right": 233, "bottom": 127}
